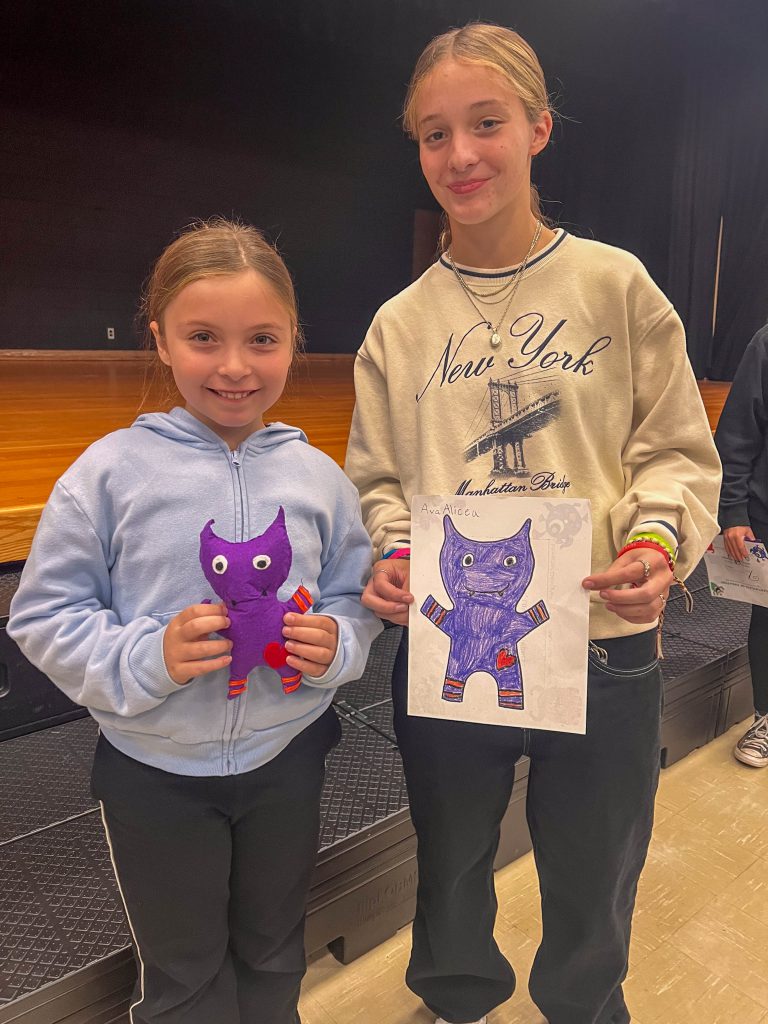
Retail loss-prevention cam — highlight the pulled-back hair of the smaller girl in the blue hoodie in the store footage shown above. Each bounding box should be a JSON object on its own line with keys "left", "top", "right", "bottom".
{"left": 140, "top": 217, "right": 303, "bottom": 349}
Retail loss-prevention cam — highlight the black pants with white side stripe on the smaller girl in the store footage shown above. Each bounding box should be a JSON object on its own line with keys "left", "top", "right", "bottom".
{"left": 92, "top": 709, "right": 340, "bottom": 1024}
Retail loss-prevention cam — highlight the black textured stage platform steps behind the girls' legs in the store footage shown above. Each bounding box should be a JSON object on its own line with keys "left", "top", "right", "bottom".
{"left": 0, "top": 566, "right": 752, "bottom": 1024}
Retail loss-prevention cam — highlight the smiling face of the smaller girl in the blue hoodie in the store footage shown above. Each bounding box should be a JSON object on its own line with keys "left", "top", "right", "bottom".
{"left": 150, "top": 269, "right": 294, "bottom": 449}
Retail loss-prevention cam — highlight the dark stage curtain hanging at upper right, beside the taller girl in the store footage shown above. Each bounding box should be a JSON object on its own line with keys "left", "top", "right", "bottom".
{"left": 668, "top": 0, "right": 768, "bottom": 380}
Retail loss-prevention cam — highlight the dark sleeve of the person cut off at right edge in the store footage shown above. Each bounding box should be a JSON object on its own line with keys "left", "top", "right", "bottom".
{"left": 715, "top": 328, "right": 768, "bottom": 528}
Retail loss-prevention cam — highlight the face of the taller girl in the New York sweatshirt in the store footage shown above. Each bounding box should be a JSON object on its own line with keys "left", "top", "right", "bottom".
{"left": 416, "top": 58, "right": 552, "bottom": 236}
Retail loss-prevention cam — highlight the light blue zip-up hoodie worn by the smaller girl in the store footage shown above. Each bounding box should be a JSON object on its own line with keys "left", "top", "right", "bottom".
{"left": 8, "top": 409, "right": 381, "bottom": 776}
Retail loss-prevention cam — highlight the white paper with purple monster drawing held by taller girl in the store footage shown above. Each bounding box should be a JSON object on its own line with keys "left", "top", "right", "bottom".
{"left": 409, "top": 496, "right": 592, "bottom": 732}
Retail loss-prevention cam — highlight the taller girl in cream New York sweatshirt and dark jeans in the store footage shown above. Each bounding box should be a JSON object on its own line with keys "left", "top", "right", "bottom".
{"left": 347, "top": 25, "right": 720, "bottom": 1024}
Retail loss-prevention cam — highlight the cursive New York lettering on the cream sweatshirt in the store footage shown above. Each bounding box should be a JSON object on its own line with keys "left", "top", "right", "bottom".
{"left": 416, "top": 312, "right": 611, "bottom": 401}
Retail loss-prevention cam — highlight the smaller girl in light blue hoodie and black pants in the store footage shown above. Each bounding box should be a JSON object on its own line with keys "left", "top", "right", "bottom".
{"left": 8, "top": 221, "right": 380, "bottom": 1024}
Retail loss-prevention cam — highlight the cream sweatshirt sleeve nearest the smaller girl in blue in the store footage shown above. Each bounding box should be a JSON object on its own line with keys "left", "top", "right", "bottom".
{"left": 344, "top": 331, "right": 411, "bottom": 558}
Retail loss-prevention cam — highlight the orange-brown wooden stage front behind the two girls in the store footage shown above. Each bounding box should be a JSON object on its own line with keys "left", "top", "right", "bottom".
{"left": 0, "top": 348, "right": 730, "bottom": 563}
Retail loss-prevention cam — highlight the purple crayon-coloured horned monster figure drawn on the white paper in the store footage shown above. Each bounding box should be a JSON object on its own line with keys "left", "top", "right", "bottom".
{"left": 421, "top": 515, "right": 549, "bottom": 710}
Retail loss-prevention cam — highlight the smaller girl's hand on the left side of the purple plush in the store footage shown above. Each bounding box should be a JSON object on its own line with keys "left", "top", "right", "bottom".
{"left": 163, "top": 604, "right": 232, "bottom": 686}
